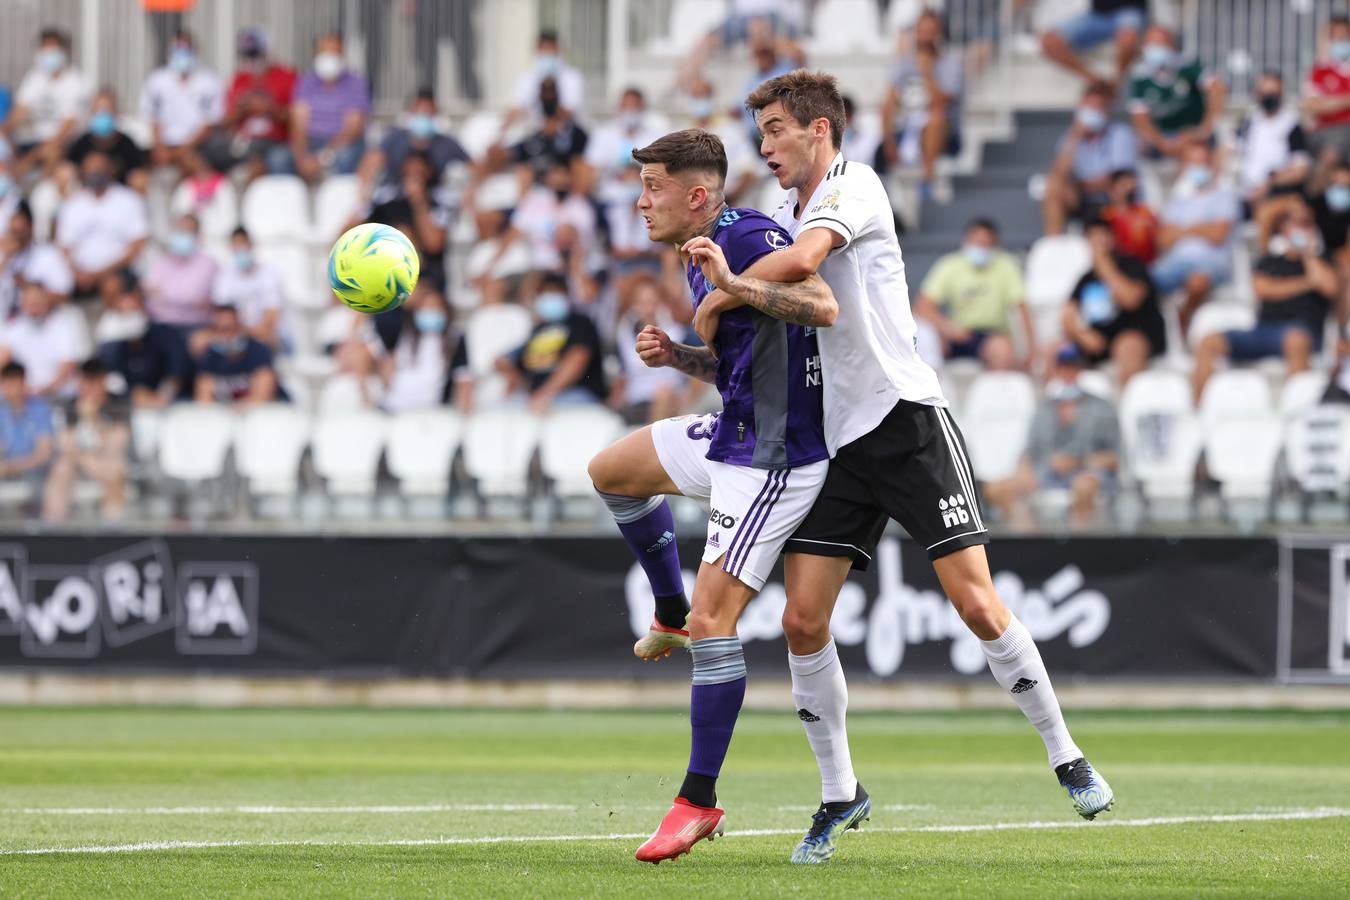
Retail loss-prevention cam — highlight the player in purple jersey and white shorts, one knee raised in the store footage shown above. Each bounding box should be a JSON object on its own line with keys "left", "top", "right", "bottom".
{"left": 590, "top": 130, "right": 836, "bottom": 862}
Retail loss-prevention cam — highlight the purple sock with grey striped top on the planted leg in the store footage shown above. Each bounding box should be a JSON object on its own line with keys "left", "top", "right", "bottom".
{"left": 680, "top": 637, "right": 745, "bottom": 807}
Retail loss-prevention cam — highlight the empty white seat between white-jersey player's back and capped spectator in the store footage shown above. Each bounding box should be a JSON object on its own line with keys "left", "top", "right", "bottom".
{"left": 960, "top": 372, "right": 1035, "bottom": 482}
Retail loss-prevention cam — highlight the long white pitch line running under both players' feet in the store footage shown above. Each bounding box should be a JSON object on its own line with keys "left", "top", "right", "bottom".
{"left": 0, "top": 807, "right": 1350, "bottom": 857}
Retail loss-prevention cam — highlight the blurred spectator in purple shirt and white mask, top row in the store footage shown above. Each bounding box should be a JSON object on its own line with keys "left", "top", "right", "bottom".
{"left": 284, "top": 32, "right": 370, "bottom": 181}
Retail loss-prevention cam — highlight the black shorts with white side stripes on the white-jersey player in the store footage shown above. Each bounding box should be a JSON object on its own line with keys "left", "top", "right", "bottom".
{"left": 783, "top": 399, "right": 990, "bottom": 571}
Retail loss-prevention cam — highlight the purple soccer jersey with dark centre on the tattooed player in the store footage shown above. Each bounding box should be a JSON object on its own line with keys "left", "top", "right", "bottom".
{"left": 686, "top": 208, "right": 829, "bottom": 468}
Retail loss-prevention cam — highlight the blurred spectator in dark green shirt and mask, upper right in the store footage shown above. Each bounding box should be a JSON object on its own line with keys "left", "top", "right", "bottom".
{"left": 1130, "top": 24, "right": 1227, "bottom": 157}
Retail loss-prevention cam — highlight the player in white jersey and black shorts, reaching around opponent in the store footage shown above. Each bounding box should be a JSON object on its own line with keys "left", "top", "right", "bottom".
{"left": 686, "top": 70, "right": 1114, "bottom": 843}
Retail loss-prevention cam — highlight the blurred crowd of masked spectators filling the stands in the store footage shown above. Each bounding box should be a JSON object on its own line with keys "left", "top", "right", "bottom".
{"left": 0, "top": 0, "right": 1350, "bottom": 519}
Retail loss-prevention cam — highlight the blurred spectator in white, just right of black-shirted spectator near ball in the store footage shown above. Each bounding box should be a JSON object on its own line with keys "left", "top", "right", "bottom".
{"left": 455, "top": 177, "right": 533, "bottom": 309}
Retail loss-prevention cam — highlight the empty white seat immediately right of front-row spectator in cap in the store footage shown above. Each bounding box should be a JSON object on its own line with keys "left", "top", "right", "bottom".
{"left": 1119, "top": 370, "right": 1200, "bottom": 501}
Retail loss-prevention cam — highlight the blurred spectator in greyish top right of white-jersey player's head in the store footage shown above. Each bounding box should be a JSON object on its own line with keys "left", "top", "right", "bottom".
{"left": 882, "top": 9, "right": 965, "bottom": 185}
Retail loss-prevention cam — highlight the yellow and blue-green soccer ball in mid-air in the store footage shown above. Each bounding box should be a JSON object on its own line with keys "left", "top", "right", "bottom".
{"left": 328, "top": 223, "right": 421, "bottom": 313}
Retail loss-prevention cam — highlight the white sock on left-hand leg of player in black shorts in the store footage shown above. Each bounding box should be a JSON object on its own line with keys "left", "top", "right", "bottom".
{"left": 787, "top": 638, "right": 857, "bottom": 803}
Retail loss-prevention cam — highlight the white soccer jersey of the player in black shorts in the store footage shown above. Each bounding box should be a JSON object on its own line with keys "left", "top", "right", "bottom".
{"left": 774, "top": 154, "right": 946, "bottom": 456}
